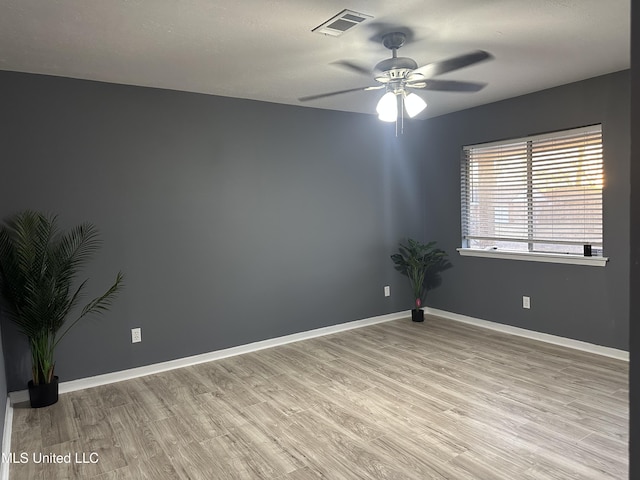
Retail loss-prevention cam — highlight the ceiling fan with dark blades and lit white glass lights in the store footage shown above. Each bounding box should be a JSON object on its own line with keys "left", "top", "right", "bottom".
{"left": 298, "top": 32, "right": 493, "bottom": 122}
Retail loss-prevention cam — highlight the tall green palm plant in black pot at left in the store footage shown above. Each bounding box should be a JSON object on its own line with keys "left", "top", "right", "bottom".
{"left": 0, "top": 210, "right": 123, "bottom": 407}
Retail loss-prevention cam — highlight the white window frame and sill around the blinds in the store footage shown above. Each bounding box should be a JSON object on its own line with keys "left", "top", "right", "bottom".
{"left": 457, "top": 123, "right": 609, "bottom": 266}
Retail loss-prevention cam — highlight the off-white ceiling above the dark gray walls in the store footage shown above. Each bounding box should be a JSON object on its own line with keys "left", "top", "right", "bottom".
{"left": 0, "top": 0, "right": 631, "bottom": 117}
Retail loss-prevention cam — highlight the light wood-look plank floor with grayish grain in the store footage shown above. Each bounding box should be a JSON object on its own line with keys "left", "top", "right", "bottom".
{"left": 10, "top": 317, "right": 628, "bottom": 480}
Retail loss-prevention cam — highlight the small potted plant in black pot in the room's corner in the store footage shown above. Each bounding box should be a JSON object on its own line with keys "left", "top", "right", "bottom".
{"left": 391, "top": 238, "right": 452, "bottom": 322}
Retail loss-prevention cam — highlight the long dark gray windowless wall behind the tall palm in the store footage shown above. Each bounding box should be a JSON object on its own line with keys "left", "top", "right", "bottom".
{"left": 0, "top": 72, "right": 420, "bottom": 390}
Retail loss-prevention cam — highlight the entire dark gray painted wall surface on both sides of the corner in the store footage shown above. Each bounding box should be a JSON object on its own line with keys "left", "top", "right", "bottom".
{"left": 0, "top": 72, "right": 630, "bottom": 390}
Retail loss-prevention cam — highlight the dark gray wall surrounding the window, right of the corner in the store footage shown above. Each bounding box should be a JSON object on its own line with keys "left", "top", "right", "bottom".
{"left": 422, "top": 71, "right": 630, "bottom": 350}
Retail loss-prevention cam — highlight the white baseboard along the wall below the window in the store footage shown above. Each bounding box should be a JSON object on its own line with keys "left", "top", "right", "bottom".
{"left": 424, "top": 307, "right": 629, "bottom": 362}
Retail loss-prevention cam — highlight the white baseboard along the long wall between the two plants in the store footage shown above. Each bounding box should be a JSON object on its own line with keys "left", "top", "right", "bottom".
{"left": 9, "top": 311, "right": 410, "bottom": 405}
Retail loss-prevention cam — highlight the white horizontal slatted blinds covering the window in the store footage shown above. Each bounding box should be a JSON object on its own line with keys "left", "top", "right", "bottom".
{"left": 461, "top": 125, "right": 603, "bottom": 255}
